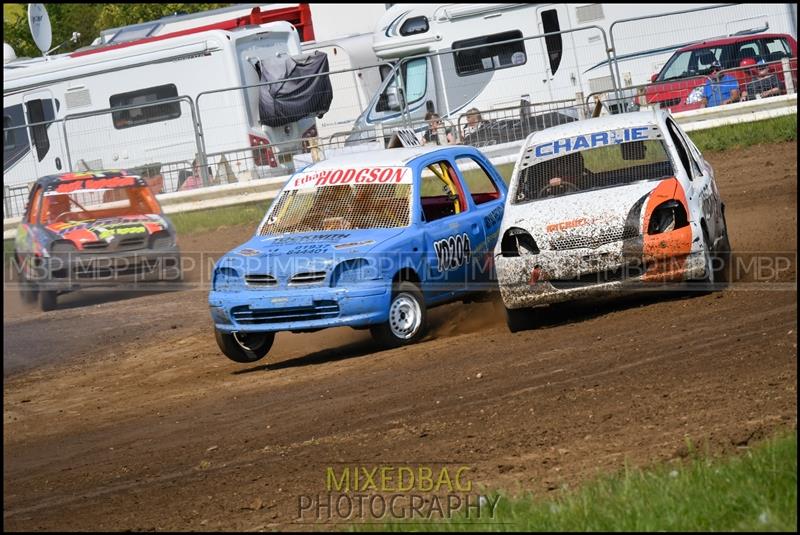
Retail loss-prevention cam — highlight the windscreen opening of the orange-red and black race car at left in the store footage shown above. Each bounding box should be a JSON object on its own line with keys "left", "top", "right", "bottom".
{"left": 41, "top": 185, "right": 161, "bottom": 225}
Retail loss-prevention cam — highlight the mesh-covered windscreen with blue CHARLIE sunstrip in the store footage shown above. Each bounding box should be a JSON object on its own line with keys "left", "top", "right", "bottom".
{"left": 513, "top": 129, "right": 674, "bottom": 204}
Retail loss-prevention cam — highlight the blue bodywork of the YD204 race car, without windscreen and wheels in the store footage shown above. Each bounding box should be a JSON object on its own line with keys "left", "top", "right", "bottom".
{"left": 209, "top": 146, "right": 507, "bottom": 333}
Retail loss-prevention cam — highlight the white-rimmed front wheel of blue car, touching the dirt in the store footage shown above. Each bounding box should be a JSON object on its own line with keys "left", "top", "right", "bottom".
{"left": 370, "top": 282, "right": 428, "bottom": 347}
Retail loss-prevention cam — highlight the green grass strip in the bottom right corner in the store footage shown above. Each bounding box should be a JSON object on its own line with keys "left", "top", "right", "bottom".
{"left": 357, "top": 434, "right": 797, "bottom": 531}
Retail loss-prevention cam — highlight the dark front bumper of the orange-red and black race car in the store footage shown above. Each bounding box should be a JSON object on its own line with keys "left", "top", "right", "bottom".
{"left": 31, "top": 246, "right": 181, "bottom": 291}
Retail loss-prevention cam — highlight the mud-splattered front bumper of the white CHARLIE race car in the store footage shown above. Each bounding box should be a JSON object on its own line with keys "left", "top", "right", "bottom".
{"left": 495, "top": 246, "right": 706, "bottom": 309}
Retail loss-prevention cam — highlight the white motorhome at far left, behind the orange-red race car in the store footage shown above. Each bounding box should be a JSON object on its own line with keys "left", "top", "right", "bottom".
{"left": 3, "top": 22, "right": 314, "bottom": 197}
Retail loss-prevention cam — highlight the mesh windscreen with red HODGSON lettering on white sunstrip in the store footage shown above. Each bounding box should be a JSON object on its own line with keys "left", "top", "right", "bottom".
{"left": 259, "top": 167, "right": 412, "bottom": 236}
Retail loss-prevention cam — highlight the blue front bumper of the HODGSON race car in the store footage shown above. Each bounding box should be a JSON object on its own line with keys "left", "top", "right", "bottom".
{"left": 208, "top": 281, "right": 391, "bottom": 332}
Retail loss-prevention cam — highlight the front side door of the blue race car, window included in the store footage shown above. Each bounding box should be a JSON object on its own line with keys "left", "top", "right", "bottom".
{"left": 417, "top": 158, "right": 485, "bottom": 302}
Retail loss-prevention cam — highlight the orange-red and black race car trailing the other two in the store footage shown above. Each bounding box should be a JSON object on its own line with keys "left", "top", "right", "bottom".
{"left": 14, "top": 171, "right": 181, "bottom": 310}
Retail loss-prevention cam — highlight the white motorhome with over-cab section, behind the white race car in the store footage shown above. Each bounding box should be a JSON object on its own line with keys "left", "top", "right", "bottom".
{"left": 349, "top": 4, "right": 796, "bottom": 142}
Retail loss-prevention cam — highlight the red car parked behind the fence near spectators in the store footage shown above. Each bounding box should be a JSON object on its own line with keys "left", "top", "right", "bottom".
{"left": 640, "top": 33, "right": 797, "bottom": 113}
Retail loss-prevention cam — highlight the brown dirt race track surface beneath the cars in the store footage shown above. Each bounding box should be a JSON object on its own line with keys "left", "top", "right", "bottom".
{"left": 3, "top": 143, "right": 797, "bottom": 530}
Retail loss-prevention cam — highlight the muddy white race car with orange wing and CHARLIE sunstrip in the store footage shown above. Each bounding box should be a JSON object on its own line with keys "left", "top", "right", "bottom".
{"left": 494, "top": 111, "right": 730, "bottom": 332}
